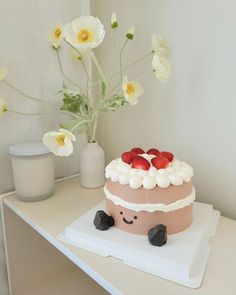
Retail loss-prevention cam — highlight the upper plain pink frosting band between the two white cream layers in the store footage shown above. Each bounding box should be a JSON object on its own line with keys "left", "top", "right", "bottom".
{"left": 106, "top": 180, "right": 193, "bottom": 205}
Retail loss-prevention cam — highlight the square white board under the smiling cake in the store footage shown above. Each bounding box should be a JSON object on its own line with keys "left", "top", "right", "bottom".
{"left": 57, "top": 202, "right": 220, "bottom": 288}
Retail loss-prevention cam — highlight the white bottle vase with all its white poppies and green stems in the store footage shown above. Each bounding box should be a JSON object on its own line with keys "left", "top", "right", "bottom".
{"left": 0, "top": 13, "right": 171, "bottom": 187}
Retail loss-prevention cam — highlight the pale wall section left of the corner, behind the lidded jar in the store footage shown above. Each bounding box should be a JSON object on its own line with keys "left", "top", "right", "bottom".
{"left": 0, "top": 0, "right": 88, "bottom": 295}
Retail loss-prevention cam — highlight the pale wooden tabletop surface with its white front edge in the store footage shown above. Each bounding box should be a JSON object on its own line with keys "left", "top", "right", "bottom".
{"left": 1, "top": 177, "right": 236, "bottom": 295}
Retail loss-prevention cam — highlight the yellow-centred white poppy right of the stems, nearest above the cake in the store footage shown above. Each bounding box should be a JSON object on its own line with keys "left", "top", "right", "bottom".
{"left": 122, "top": 76, "right": 144, "bottom": 105}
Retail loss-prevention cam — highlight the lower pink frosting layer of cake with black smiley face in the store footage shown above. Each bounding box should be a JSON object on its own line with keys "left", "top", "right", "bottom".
{"left": 106, "top": 199, "right": 192, "bottom": 235}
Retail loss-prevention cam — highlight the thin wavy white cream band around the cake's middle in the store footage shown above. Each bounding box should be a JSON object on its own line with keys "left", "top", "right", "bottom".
{"left": 103, "top": 186, "right": 195, "bottom": 212}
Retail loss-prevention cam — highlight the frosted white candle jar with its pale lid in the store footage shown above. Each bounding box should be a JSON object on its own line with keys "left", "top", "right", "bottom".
{"left": 9, "top": 142, "right": 55, "bottom": 202}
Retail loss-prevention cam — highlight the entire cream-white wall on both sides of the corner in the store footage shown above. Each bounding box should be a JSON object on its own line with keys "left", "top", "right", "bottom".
{"left": 0, "top": 0, "right": 236, "bottom": 294}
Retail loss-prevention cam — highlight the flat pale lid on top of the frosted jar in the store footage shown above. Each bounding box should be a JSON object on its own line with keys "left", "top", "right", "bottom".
{"left": 9, "top": 142, "right": 50, "bottom": 156}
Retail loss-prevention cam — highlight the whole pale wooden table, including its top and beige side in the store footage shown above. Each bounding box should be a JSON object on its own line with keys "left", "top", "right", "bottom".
{"left": 2, "top": 177, "right": 236, "bottom": 295}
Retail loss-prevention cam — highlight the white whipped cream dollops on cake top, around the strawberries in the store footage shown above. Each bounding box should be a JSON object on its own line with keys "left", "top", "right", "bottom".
{"left": 105, "top": 154, "right": 193, "bottom": 189}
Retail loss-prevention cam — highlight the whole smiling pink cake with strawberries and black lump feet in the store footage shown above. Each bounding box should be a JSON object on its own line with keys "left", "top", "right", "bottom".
{"left": 94, "top": 148, "right": 195, "bottom": 246}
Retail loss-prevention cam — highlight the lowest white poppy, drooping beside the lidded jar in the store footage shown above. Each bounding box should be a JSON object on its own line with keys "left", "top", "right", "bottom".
{"left": 43, "top": 129, "right": 76, "bottom": 157}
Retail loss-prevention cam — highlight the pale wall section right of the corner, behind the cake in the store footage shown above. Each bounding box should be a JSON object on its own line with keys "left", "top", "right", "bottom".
{"left": 92, "top": 0, "right": 236, "bottom": 218}
